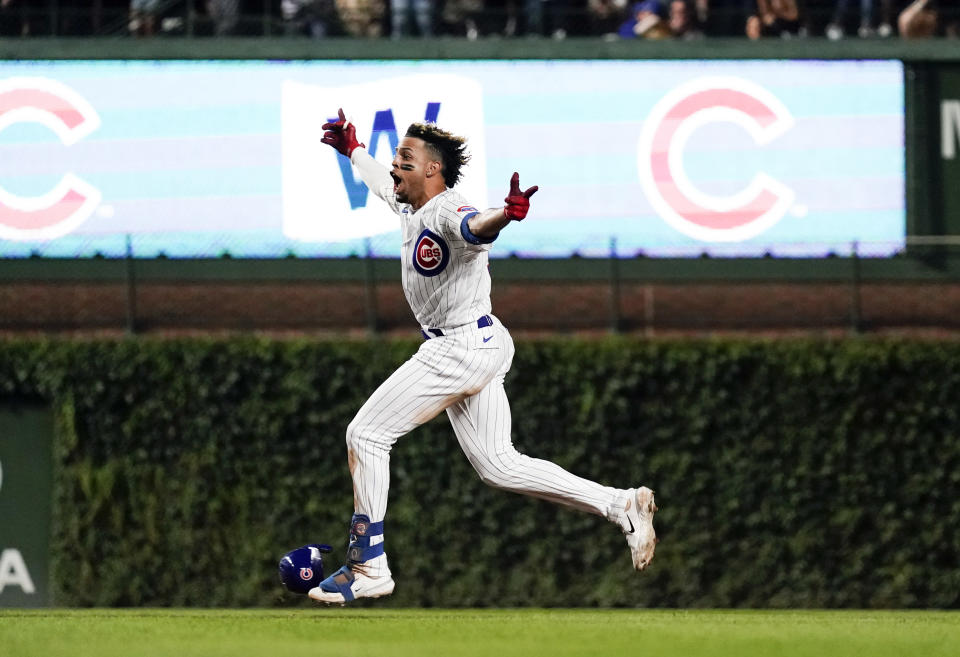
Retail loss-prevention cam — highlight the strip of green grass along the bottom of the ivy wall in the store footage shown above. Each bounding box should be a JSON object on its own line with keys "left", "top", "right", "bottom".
{"left": 0, "top": 607, "right": 960, "bottom": 657}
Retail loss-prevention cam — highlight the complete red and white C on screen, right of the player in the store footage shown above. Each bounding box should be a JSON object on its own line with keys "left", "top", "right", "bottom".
{"left": 639, "top": 77, "right": 794, "bottom": 242}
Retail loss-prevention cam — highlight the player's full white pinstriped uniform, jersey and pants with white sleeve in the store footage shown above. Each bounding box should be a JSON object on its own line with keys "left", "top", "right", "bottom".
{"left": 334, "top": 148, "right": 633, "bottom": 572}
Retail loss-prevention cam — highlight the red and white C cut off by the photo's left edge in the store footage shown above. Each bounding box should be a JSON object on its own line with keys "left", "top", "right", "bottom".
{"left": 0, "top": 78, "right": 100, "bottom": 240}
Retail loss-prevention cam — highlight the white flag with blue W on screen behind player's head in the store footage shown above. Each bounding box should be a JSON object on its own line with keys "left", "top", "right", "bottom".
{"left": 281, "top": 71, "right": 486, "bottom": 242}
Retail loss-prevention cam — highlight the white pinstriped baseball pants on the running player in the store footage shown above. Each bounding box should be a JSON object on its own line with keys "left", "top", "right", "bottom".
{"left": 347, "top": 315, "right": 624, "bottom": 522}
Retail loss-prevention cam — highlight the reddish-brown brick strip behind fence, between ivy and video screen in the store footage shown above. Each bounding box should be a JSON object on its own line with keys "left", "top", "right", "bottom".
{"left": 0, "top": 280, "right": 960, "bottom": 335}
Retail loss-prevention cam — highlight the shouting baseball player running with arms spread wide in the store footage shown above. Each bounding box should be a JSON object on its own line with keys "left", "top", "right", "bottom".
{"left": 309, "top": 110, "right": 657, "bottom": 603}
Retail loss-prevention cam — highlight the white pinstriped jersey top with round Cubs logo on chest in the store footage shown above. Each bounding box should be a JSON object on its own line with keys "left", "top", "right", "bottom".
{"left": 362, "top": 156, "right": 492, "bottom": 328}
